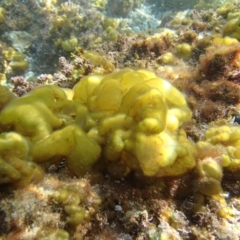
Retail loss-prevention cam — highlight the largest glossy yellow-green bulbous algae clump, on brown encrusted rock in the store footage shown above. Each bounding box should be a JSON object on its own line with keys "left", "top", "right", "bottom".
{"left": 0, "top": 69, "right": 195, "bottom": 183}
